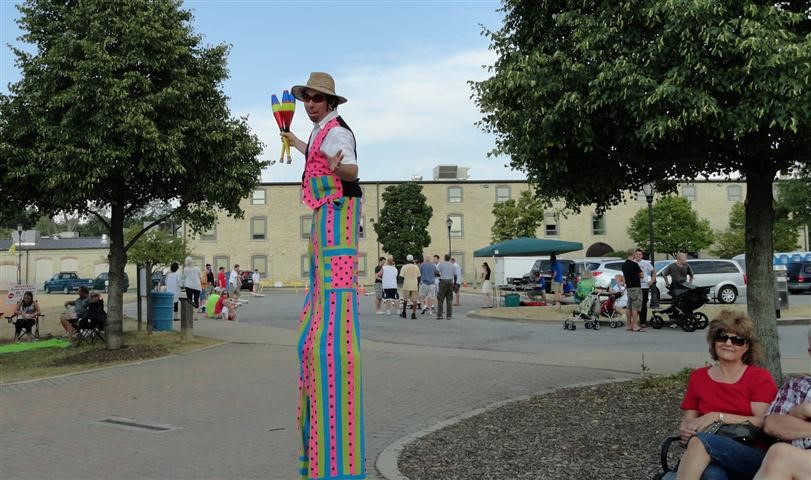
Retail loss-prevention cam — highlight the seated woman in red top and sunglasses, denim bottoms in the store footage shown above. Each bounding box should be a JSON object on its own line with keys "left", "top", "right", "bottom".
{"left": 678, "top": 310, "right": 777, "bottom": 480}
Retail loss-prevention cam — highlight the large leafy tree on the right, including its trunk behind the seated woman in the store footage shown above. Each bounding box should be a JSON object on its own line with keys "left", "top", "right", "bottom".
{"left": 474, "top": 0, "right": 811, "bottom": 379}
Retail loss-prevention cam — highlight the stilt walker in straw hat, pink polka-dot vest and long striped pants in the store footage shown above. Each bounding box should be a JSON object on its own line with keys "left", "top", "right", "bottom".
{"left": 282, "top": 72, "right": 366, "bottom": 479}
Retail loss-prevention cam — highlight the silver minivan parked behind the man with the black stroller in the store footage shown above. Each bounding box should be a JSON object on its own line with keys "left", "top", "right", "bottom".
{"left": 656, "top": 258, "right": 748, "bottom": 303}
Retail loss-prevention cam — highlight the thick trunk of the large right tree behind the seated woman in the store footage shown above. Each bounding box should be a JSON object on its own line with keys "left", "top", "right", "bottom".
{"left": 745, "top": 172, "right": 783, "bottom": 385}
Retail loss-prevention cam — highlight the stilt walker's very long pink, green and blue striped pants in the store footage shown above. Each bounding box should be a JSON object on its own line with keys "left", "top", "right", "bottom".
{"left": 298, "top": 197, "right": 366, "bottom": 479}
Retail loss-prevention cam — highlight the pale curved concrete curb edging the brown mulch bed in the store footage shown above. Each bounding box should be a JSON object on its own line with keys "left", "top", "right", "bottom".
{"left": 375, "top": 379, "right": 629, "bottom": 480}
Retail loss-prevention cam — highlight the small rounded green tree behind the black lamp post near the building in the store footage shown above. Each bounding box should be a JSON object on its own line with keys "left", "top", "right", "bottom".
{"left": 628, "top": 196, "right": 716, "bottom": 256}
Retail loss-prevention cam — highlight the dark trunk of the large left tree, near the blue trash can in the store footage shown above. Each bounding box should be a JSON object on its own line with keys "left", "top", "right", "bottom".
{"left": 105, "top": 205, "right": 126, "bottom": 350}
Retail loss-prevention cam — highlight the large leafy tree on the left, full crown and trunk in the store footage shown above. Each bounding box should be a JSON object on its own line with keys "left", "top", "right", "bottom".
{"left": 0, "top": 0, "right": 264, "bottom": 349}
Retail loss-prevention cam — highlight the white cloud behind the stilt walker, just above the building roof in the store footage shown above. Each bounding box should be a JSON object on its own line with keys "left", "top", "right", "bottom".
{"left": 236, "top": 50, "right": 523, "bottom": 181}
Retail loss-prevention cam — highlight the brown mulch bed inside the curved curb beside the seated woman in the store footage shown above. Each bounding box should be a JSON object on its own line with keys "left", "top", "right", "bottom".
{"left": 398, "top": 373, "right": 687, "bottom": 480}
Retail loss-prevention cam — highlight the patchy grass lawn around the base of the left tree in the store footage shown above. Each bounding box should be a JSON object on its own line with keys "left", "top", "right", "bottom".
{"left": 0, "top": 292, "right": 220, "bottom": 383}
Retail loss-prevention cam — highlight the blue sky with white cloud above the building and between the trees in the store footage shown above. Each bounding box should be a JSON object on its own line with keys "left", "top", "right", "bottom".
{"left": 0, "top": 0, "right": 525, "bottom": 181}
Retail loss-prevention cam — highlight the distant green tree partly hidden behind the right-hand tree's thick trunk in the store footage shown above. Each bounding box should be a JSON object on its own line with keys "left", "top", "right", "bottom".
{"left": 711, "top": 202, "right": 798, "bottom": 258}
